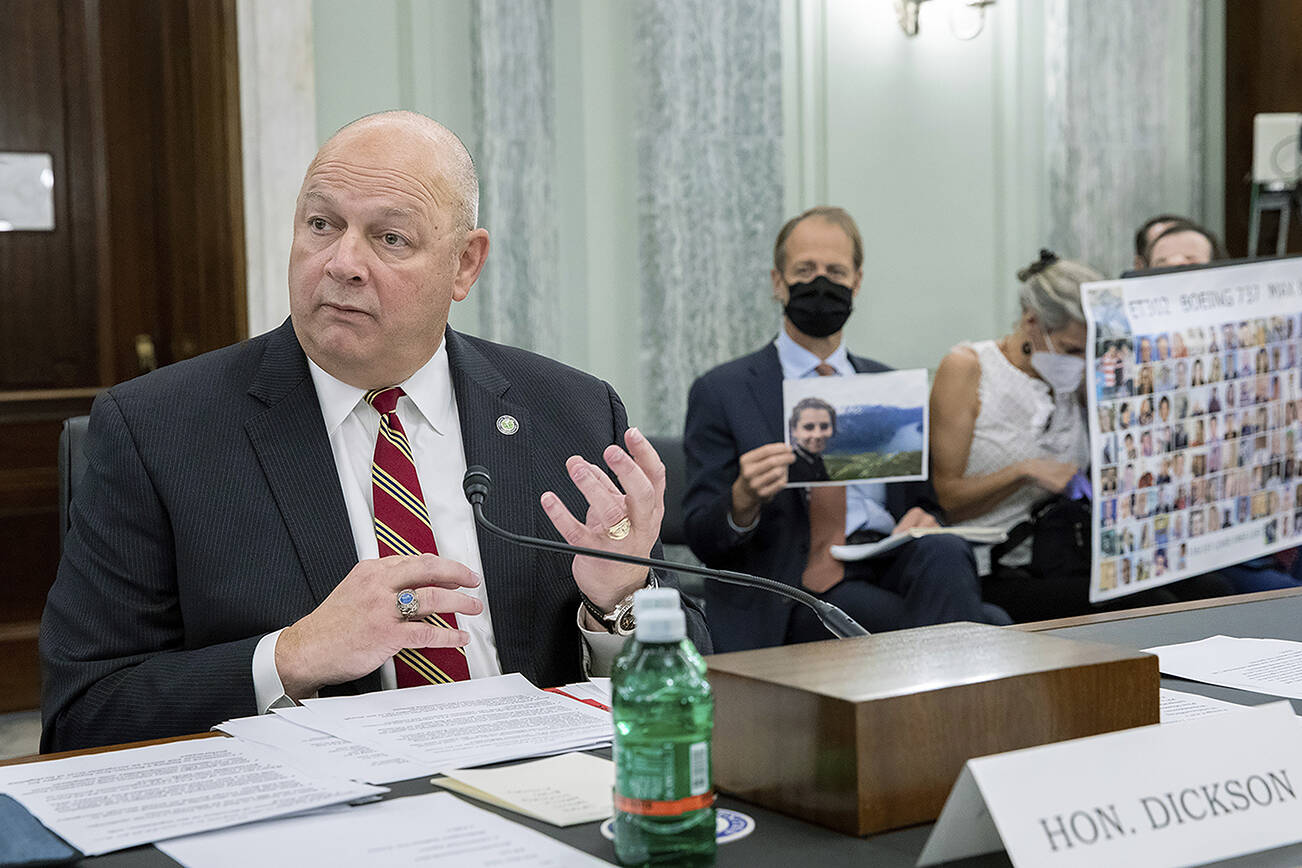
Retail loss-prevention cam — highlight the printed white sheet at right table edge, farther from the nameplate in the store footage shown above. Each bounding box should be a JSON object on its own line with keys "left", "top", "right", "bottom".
{"left": 1144, "top": 636, "right": 1302, "bottom": 699}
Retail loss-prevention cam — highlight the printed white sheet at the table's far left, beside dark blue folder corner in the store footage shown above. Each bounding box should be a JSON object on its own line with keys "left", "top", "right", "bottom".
{"left": 0, "top": 738, "right": 387, "bottom": 855}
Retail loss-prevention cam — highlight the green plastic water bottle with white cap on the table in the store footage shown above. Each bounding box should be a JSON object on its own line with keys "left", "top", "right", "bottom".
{"left": 612, "top": 591, "right": 715, "bottom": 865}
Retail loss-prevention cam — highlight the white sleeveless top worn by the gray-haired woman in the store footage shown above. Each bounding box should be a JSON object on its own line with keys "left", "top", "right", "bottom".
{"left": 954, "top": 341, "right": 1090, "bottom": 573}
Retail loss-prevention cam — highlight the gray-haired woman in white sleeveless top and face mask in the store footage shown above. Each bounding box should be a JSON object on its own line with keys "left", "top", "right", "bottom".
{"left": 931, "top": 250, "right": 1103, "bottom": 621}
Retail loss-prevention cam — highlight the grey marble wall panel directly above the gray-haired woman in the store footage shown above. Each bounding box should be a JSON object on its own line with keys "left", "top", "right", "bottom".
{"left": 1044, "top": 0, "right": 1206, "bottom": 276}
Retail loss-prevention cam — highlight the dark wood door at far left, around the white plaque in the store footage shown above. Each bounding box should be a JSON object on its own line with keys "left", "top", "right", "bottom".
{"left": 0, "top": 0, "right": 102, "bottom": 711}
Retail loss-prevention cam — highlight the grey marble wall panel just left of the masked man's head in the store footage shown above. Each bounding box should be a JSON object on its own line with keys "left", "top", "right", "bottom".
{"left": 634, "top": 0, "right": 784, "bottom": 432}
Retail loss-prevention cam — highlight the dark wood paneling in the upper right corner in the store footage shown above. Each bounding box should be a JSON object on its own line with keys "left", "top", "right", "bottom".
{"left": 1225, "top": 0, "right": 1302, "bottom": 256}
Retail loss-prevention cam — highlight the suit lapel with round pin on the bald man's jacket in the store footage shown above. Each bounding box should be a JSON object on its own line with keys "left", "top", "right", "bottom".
{"left": 445, "top": 328, "right": 539, "bottom": 683}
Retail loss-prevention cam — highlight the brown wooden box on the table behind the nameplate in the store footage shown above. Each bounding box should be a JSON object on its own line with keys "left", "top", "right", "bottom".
{"left": 706, "top": 623, "right": 1159, "bottom": 835}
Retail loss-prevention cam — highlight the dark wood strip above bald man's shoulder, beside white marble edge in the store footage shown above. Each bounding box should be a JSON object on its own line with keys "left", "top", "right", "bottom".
{"left": 100, "top": 0, "right": 246, "bottom": 381}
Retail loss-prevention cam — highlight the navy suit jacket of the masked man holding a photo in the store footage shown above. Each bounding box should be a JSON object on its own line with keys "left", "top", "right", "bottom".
{"left": 682, "top": 344, "right": 939, "bottom": 651}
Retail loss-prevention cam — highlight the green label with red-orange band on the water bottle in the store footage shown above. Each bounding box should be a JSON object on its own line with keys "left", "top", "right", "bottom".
{"left": 615, "top": 742, "right": 715, "bottom": 816}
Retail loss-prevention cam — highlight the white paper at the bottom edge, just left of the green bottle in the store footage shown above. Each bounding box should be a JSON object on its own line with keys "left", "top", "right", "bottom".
{"left": 159, "top": 796, "right": 609, "bottom": 868}
